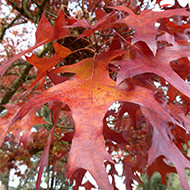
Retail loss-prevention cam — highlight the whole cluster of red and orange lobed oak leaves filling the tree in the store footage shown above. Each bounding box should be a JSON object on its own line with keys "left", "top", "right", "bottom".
{"left": 0, "top": 0, "right": 190, "bottom": 190}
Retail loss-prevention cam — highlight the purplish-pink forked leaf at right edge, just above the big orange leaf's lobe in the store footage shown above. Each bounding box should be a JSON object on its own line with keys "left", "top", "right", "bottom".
{"left": 117, "top": 42, "right": 190, "bottom": 97}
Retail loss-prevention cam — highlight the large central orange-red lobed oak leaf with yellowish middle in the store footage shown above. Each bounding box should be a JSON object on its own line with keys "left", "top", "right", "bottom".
{"left": 10, "top": 51, "right": 171, "bottom": 189}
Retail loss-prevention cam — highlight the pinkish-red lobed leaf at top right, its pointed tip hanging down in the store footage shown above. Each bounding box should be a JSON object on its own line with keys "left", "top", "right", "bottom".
{"left": 112, "top": 6, "right": 190, "bottom": 56}
